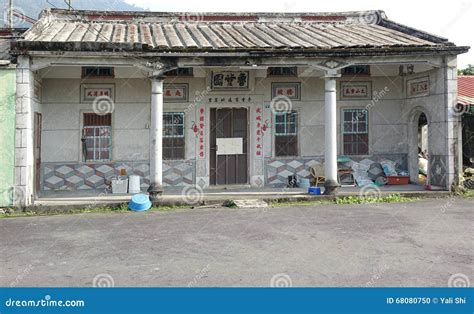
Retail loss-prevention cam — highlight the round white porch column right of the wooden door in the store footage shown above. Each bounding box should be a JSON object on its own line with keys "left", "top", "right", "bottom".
{"left": 324, "top": 71, "right": 339, "bottom": 195}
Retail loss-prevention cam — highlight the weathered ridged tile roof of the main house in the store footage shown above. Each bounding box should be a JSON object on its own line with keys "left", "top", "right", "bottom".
{"left": 13, "top": 9, "right": 465, "bottom": 52}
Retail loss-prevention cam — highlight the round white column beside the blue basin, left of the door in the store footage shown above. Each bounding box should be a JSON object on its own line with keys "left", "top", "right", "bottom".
{"left": 148, "top": 77, "right": 163, "bottom": 199}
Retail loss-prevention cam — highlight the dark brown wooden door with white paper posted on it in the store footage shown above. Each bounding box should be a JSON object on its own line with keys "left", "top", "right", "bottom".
{"left": 210, "top": 108, "right": 248, "bottom": 185}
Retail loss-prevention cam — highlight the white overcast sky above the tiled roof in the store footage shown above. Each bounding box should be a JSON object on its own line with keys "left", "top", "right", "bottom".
{"left": 126, "top": 0, "right": 474, "bottom": 68}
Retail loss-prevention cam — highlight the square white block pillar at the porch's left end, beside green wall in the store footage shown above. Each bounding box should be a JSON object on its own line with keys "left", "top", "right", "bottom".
{"left": 13, "top": 55, "right": 35, "bottom": 207}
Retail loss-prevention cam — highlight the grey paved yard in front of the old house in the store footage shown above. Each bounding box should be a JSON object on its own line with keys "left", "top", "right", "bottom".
{"left": 0, "top": 199, "right": 474, "bottom": 286}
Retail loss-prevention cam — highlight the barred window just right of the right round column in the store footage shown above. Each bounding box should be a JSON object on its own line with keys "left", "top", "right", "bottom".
{"left": 342, "top": 109, "right": 369, "bottom": 155}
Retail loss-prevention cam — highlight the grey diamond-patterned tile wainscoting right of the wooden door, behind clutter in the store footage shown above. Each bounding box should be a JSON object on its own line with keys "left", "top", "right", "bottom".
{"left": 265, "top": 154, "right": 408, "bottom": 187}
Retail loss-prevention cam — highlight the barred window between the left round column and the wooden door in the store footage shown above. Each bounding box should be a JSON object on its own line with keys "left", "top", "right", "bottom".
{"left": 163, "top": 112, "right": 184, "bottom": 159}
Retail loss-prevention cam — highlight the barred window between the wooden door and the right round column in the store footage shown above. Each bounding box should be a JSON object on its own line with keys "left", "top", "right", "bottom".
{"left": 275, "top": 111, "right": 298, "bottom": 156}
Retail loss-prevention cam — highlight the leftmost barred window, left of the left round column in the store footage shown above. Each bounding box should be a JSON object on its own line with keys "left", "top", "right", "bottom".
{"left": 82, "top": 113, "right": 112, "bottom": 161}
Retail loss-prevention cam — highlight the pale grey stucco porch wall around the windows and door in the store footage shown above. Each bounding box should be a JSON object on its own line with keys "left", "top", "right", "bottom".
{"left": 42, "top": 68, "right": 454, "bottom": 190}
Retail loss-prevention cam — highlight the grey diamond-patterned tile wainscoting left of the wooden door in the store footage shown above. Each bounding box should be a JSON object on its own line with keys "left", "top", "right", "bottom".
{"left": 41, "top": 160, "right": 195, "bottom": 191}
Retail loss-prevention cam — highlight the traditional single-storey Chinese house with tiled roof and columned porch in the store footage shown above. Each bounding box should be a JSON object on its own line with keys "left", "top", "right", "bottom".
{"left": 9, "top": 9, "right": 469, "bottom": 205}
